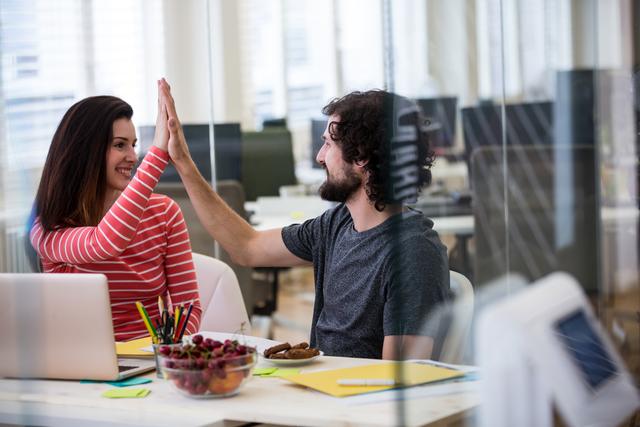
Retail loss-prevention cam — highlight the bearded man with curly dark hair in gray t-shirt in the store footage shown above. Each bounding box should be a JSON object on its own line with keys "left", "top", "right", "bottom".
{"left": 168, "top": 91, "right": 449, "bottom": 359}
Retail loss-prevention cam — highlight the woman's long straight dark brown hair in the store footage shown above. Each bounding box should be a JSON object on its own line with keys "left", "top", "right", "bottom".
{"left": 35, "top": 96, "right": 133, "bottom": 231}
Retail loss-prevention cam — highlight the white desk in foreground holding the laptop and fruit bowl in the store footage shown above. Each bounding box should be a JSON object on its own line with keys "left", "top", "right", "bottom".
{"left": 0, "top": 356, "right": 479, "bottom": 427}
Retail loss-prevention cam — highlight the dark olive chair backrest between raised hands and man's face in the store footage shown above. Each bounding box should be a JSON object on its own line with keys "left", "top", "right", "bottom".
{"left": 242, "top": 128, "right": 297, "bottom": 200}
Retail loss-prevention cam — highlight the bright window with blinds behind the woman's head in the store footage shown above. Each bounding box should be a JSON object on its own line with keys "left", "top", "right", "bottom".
{"left": 0, "top": 0, "right": 162, "bottom": 270}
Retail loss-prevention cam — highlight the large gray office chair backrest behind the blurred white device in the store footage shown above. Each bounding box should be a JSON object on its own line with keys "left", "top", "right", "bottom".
{"left": 472, "top": 146, "right": 599, "bottom": 294}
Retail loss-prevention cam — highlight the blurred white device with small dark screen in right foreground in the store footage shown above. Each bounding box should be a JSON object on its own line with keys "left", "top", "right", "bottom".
{"left": 475, "top": 272, "right": 640, "bottom": 427}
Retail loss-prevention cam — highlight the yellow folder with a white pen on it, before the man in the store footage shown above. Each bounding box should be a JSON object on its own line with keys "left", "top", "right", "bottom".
{"left": 282, "top": 362, "right": 464, "bottom": 397}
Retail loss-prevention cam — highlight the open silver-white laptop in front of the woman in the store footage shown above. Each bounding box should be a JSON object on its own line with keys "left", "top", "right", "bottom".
{"left": 0, "top": 273, "right": 155, "bottom": 380}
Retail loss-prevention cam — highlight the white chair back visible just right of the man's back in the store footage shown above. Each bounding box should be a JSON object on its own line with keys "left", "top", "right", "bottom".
{"left": 439, "top": 271, "right": 474, "bottom": 363}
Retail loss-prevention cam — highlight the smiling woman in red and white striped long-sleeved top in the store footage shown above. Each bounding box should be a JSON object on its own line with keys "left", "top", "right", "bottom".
{"left": 30, "top": 79, "right": 201, "bottom": 341}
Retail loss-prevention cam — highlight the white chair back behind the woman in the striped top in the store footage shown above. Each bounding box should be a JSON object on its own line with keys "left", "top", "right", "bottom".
{"left": 193, "top": 252, "right": 251, "bottom": 335}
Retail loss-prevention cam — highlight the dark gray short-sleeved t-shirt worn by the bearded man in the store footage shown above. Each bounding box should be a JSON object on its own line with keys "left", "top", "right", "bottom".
{"left": 282, "top": 204, "right": 449, "bottom": 358}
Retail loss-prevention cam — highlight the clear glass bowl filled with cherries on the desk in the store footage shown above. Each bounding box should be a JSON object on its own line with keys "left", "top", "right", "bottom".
{"left": 158, "top": 343, "right": 258, "bottom": 399}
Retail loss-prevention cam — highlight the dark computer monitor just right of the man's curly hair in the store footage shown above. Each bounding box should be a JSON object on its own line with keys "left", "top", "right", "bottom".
{"left": 416, "top": 96, "right": 458, "bottom": 155}
